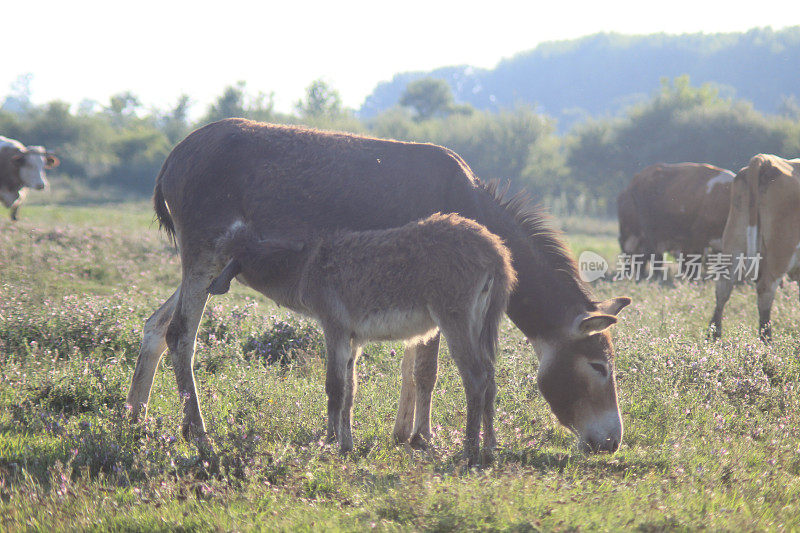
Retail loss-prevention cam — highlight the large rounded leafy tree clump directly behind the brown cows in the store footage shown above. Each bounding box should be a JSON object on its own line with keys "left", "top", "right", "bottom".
{"left": 567, "top": 76, "right": 796, "bottom": 207}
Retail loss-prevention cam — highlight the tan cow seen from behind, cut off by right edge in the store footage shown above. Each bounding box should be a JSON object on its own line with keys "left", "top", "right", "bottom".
{"left": 710, "top": 154, "right": 800, "bottom": 342}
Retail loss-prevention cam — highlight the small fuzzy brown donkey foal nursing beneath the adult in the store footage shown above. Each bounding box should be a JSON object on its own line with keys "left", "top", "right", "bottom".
{"left": 209, "top": 213, "right": 516, "bottom": 464}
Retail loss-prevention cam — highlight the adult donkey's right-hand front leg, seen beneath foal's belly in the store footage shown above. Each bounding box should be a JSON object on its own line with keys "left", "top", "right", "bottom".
{"left": 410, "top": 333, "right": 440, "bottom": 449}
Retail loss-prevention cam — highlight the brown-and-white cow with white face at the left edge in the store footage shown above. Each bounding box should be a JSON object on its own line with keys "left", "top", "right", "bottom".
{"left": 0, "top": 136, "right": 58, "bottom": 220}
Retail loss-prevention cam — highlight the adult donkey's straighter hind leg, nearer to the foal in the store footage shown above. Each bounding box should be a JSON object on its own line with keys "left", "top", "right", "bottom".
{"left": 166, "top": 268, "right": 214, "bottom": 438}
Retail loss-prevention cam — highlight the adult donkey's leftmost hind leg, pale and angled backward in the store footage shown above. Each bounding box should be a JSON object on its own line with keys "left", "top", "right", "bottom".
{"left": 126, "top": 289, "right": 180, "bottom": 421}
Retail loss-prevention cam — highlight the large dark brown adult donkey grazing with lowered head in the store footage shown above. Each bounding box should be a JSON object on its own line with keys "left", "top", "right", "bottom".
{"left": 127, "top": 119, "right": 630, "bottom": 451}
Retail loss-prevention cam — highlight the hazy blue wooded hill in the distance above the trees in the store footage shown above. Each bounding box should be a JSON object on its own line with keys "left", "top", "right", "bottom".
{"left": 359, "top": 26, "right": 800, "bottom": 130}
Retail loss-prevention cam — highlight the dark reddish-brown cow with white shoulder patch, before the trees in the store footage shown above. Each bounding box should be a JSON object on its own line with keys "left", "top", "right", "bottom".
{"left": 617, "top": 163, "right": 734, "bottom": 264}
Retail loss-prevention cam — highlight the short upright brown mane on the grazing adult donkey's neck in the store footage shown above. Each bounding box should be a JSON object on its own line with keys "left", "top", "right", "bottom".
{"left": 478, "top": 180, "right": 585, "bottom": 293}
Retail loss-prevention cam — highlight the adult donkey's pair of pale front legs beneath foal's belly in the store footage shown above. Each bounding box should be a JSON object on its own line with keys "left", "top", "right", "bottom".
{"left": 392, "top": 334, "right": 439, "bottom": 442}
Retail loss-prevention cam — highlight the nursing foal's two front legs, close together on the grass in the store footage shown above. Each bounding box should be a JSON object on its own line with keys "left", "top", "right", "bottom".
{"left": 323, "top": 325, "right": 353, "bottom": 451}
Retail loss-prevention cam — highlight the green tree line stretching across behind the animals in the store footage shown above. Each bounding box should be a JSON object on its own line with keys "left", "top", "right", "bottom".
{"left": 0, "top": 76, "right": 800, "bottom": 214}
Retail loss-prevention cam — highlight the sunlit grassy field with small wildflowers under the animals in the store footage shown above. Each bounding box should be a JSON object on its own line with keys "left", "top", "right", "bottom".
{"left": 0, "top": 203, "right": 800, "bottom": 531}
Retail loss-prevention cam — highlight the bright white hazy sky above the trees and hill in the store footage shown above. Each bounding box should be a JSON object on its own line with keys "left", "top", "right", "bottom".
{"left": 0, "top": 0, "right": 800, "bottom": 114}
